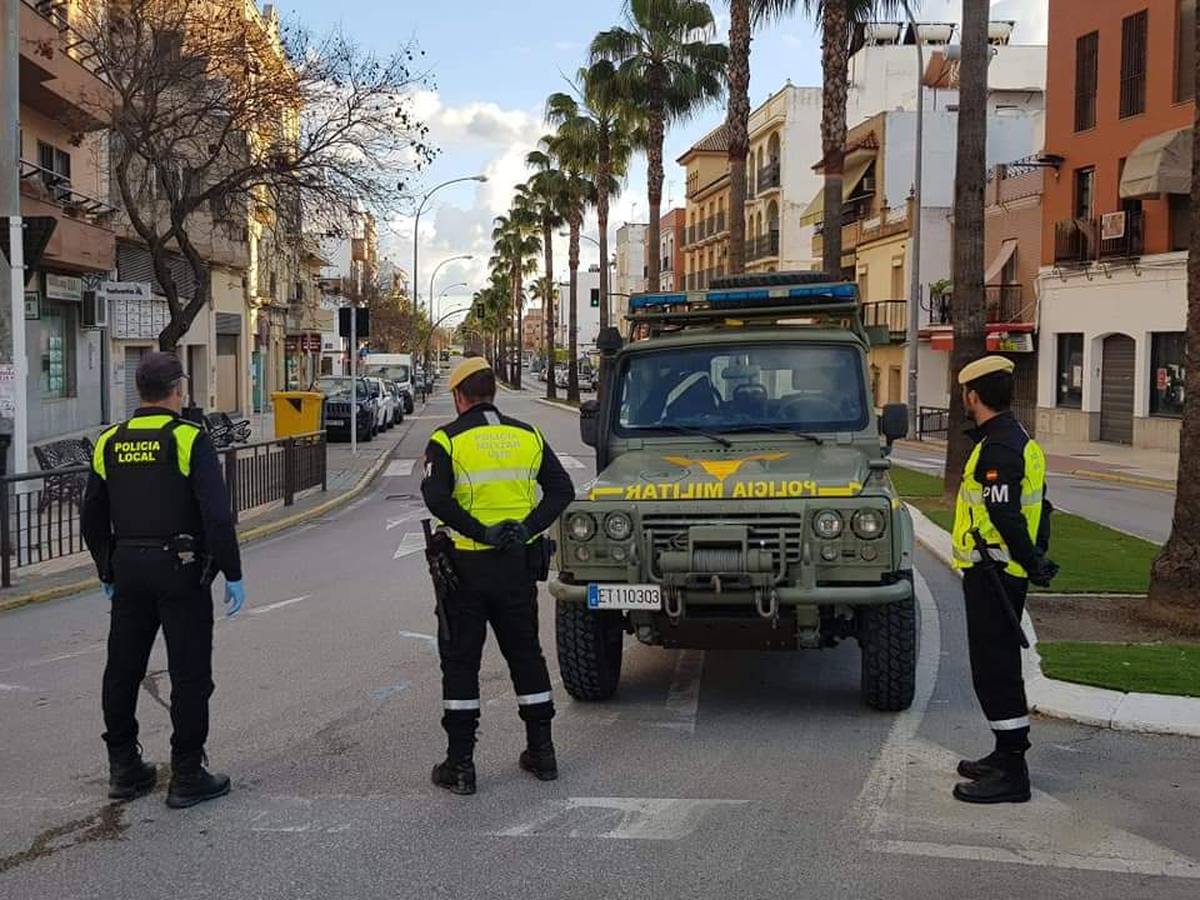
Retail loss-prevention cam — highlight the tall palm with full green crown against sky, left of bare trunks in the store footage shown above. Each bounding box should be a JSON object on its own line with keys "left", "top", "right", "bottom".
{"left": 592, "top": 0, "right": 728, "bottom": 290}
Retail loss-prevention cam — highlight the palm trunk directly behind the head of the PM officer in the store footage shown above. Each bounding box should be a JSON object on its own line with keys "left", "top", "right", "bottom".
{"left": 940, "top": 0, "right": 989, "bottom": 498}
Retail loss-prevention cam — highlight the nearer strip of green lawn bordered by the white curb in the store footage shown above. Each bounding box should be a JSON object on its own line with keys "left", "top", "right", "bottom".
{"left": 1038, "top": 641, "right": 1200, "bottom": 697}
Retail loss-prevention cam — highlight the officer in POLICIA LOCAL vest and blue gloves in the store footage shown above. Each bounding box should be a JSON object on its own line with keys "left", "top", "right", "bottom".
{"left": 83, "top": 353, "right": 245, "bottom": 809}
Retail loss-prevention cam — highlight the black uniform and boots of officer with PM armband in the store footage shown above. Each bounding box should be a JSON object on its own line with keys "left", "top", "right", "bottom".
{"left": 955, "top": 412, "right": 1057, "bottom": 803}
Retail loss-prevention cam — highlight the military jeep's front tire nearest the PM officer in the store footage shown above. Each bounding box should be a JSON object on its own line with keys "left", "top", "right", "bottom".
{"left": 858, "top": 580, "right": 917, "bottom": 713}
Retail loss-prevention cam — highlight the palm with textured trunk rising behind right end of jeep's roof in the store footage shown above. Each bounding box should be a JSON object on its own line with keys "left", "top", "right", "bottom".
{"left": 801, "top": 0, "right": 918, "bottom": 276}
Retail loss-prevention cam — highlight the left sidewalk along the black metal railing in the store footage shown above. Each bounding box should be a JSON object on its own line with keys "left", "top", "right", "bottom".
{"left": 0, "top": 420, "right": 413, "bottom": 611}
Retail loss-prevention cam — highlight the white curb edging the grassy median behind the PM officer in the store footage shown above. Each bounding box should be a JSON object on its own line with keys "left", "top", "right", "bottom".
{"left": 905, "top": 504, "right": 1200, "bottom": 737}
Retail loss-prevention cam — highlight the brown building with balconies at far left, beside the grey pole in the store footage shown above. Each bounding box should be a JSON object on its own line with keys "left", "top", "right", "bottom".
{"left": 14, "top": 0, "right": 116, "bottom": 445}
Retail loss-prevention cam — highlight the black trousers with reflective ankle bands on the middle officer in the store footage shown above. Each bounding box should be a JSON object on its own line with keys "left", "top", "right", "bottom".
{"left": 438, "top": 547, "right": 554, "bottom": 752}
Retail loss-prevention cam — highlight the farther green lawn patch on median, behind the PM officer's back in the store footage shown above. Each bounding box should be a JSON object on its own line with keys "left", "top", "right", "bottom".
{"left": 892, "top": 467, "right": 1158, "bottom": 594}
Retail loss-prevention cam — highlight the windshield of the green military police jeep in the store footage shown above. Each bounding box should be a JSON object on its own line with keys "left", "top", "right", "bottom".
{"left": 617, "top": 343, "right": 868, "bottom": 434}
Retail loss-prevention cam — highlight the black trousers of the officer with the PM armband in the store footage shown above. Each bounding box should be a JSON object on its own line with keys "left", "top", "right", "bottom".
{"left": 962, "top": 565, "right": 1030, "bottom": 750}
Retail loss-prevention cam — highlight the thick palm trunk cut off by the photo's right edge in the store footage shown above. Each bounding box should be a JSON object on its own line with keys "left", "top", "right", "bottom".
{"left": 1150, "top": 14, "right": 1200, "bottom": 628}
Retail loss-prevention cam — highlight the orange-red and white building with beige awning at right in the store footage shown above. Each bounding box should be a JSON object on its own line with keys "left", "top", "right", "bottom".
{"left": 1038, "top": 0, "right": 1196, "bottom": 450}
